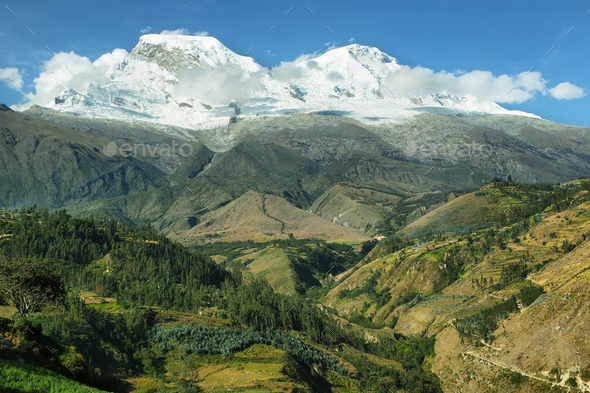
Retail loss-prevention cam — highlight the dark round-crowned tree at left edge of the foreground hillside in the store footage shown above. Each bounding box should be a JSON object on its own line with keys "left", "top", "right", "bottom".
{"left": 0, "top": 256, "right": 66, "bottom": 318}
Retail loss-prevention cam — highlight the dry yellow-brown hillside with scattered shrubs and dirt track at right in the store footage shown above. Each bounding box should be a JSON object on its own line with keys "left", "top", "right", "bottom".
{"left": 322, "top": 180, "right": 590, "bottom": 392}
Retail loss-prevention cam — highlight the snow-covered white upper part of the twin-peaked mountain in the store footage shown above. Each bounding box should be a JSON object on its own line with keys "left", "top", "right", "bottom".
{"left": 47, "top": 34, "right": 536, "bottom": 135}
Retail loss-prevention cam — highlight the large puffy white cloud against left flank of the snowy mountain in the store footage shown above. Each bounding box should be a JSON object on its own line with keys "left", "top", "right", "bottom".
{"left": 18, "top": 49, "right": 128, "bottom": 109}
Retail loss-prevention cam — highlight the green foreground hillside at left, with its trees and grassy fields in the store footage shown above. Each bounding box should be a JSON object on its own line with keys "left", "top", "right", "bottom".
{"left": 0, "top": 208, "right": 440, "bottom": 392}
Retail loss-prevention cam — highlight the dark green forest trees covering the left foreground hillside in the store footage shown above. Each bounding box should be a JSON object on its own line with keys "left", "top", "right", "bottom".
{"left": 0, "top": 206, "right": 441, "bottom": 392}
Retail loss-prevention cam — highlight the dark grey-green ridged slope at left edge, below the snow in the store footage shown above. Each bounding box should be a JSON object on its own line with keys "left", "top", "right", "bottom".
{"left": 0, "top": 105, "right": 165, "bottom": 207}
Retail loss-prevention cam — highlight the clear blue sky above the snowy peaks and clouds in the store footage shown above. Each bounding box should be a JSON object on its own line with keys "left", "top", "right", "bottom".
{"left": 0, "top": 0, "right": 590, "bottom": 127}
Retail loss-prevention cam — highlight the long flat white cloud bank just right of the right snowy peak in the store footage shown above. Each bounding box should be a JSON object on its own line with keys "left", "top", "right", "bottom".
{"left": 385, "top": 66, "right": 547, "bottom": 103}
